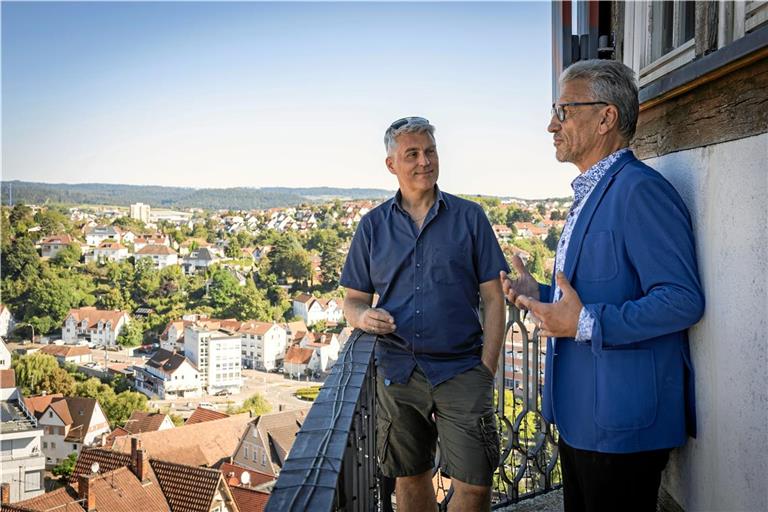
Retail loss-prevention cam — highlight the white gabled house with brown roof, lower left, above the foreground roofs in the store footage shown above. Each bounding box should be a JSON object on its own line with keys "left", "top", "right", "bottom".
{"left": 24, "top": 395, "right": 110, "bottom": 467}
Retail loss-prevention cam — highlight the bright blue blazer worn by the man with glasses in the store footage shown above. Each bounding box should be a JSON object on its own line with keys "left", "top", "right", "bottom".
{"left": 540, "top": 152, "right": 704, "bottom": 453}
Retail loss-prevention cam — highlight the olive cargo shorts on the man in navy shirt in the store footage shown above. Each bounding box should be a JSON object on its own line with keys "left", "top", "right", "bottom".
{"left": 376, "top": 363, "right": 500, "bottom": 487}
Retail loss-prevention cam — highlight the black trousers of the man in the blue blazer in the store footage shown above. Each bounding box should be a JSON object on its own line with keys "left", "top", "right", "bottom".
{"left": 558, "top": 437, "right": 670, "bottom": 512}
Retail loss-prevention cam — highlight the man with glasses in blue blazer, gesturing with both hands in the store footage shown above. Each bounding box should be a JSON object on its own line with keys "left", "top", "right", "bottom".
{"left": 502, "top": 60, "right": 704, "bottom": 512}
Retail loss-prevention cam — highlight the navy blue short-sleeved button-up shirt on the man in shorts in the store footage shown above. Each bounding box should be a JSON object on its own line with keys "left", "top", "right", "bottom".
{"left": 340, "top": 189, "right": 509, "bottom": 386}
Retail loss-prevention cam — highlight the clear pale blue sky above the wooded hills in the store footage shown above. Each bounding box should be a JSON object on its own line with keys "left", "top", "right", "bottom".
{"left": 1, "top": 2, "right": 578, "bottom": 198}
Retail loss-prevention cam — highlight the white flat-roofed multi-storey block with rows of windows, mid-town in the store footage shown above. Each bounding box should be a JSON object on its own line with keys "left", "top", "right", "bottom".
{"left": 184, "top": 325, "right": 242, "bottom": 394}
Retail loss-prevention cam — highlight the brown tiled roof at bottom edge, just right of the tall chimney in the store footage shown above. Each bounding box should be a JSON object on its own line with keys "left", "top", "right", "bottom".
{"left": 149, "top": 459, "right": 232, "bottom": 512}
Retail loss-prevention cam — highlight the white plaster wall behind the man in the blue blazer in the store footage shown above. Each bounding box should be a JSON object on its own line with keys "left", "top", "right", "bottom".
{"left": 646, "top": 134, "right": 768, "bottom": 512}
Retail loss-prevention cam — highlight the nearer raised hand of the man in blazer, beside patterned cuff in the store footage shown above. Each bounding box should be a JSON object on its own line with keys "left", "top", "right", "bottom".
{"left": 515, "top": 272, "right": 584, "bottom": 338}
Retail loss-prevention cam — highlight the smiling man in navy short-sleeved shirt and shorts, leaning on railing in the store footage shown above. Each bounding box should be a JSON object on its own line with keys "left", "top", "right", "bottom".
{"left": 341, "top": 117, "right": 508, "bottom": 512}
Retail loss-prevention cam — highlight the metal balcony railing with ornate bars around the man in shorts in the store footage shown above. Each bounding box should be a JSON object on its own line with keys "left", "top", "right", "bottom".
{"left": 266, "top": 306, "right": 561, "bottom": 512}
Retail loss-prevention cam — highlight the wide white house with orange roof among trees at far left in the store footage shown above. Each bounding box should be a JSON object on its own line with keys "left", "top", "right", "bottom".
{"left": 61, "top": 306, "right": 131, "bottom": 347}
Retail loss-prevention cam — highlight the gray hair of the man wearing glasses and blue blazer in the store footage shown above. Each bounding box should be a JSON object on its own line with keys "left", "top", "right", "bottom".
{"left": 560, "top": 59, "right": 640, "bottom": 141}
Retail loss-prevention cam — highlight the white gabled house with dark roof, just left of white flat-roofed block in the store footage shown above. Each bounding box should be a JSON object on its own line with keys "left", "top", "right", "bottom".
{"left": 135, "top": 348, "right": 202, "bottom": 400}
